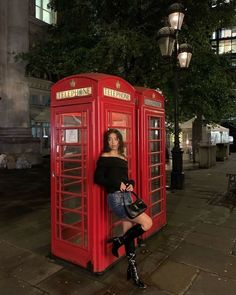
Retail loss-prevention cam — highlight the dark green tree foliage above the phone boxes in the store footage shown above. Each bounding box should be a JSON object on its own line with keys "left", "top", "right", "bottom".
{"left": 21, "top": 0, "right": 236, "bottom": 121}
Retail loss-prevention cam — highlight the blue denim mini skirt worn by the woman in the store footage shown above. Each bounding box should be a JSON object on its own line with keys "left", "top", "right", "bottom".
{"left": 107, "top": 191, "right": 132, "bottom": 219}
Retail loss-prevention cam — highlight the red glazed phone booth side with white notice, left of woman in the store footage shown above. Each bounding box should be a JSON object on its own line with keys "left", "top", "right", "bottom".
{"left": 51, "top": 105, "right": 91, "bottom": 266}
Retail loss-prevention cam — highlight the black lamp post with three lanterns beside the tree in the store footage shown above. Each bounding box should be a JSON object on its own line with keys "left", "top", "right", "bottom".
{"left": 157, "top": 3, "right": 192, "bottom": 189}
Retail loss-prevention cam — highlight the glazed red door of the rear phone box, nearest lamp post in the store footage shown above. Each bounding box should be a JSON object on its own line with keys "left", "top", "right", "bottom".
{"left": 146, "top": 112, "right": 166, "bottom": 235}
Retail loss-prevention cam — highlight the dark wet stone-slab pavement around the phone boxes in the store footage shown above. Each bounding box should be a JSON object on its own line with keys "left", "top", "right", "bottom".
{"left": 0, "top": 154, "right": 236, "bottom": 295}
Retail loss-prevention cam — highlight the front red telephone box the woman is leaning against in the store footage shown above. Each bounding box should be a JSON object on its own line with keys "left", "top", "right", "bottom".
{"left": 51, "top": 73, "right": 136, "bottom": 273}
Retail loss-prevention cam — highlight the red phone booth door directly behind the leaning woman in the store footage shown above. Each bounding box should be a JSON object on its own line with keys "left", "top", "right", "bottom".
{"left": 105, "top": 105, "right": 136, "bottom": 255}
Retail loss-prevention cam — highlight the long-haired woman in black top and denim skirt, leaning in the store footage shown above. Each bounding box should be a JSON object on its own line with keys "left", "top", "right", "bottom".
{"left": 94, "top": 129, "right": 152, "bottom": 289}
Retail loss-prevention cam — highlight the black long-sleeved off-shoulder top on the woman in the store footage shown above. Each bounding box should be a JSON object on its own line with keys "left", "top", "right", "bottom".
{"left": 94, "top": 156, "right": 134, "bottom": 193}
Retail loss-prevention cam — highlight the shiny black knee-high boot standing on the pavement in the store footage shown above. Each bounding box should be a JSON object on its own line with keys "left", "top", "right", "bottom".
{"left": 125, "top": 240, "right": 147, "bottom": 289}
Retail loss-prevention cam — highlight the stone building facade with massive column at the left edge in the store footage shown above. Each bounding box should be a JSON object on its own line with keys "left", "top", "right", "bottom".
{"left": 0, "top": 0, "right": 51, "bottom": 168}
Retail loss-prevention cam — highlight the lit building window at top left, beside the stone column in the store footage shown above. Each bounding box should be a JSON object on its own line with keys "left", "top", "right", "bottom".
{"left": 35, "top": 0, "right": 56, "bottom": 24}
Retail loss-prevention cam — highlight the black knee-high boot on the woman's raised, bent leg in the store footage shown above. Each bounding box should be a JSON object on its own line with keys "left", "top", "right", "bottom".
{"left": 108, "top": 224, "right": 145, "bottom": 257}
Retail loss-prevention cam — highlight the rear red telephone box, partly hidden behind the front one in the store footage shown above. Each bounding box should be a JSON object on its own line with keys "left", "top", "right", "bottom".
{"left": 135, "top": 87, "right": 166, "bottom": 238}
